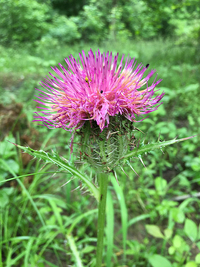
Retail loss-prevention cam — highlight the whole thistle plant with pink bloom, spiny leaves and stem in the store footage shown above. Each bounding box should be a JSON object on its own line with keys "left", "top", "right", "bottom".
{"left": 18, "top": 50, "right": 195, "bottom": 267}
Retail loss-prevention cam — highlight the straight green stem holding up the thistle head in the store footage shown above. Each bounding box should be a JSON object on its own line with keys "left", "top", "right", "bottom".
{"left": 96, "top": 173, "right": 108, "bottom": 267}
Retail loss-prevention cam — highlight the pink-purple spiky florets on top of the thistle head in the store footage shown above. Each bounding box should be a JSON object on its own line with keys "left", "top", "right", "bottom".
{"left": 35, "top": 50, "right": 164, "bottom": 131}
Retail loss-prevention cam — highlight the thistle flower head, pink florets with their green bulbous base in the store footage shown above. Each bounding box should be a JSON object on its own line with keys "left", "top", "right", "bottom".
{"left": 35, "top": 50, "right": 164, "bottom": 171}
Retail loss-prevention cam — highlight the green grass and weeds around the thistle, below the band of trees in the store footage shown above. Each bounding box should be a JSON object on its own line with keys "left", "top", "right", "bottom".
{"left": 0, "top": 40, "right": 200, "bottom": 267}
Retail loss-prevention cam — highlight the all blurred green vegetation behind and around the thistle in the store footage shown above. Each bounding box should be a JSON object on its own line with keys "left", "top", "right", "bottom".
{"left": 0, "top": 0, "right": 200, "bottom": 267}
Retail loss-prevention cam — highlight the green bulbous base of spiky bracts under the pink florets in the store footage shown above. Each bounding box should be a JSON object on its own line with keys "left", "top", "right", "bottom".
{"left": 77, "top": 116, "right": 141, "bottom": 172}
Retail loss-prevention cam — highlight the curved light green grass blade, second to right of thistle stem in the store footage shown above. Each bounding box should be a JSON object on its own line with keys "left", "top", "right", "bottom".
{"left": 111, "top": 177, "right": 128, "bottom": 262}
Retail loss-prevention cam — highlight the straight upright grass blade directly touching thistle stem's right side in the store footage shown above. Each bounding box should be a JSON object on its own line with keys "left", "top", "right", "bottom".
{"left": 106, "top": 189, "right": 114, "bottom": 266}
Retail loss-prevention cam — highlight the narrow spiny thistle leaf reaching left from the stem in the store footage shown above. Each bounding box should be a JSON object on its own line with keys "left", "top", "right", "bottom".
{"left": 14, "top": 144, "right": 99, "bottom": 201}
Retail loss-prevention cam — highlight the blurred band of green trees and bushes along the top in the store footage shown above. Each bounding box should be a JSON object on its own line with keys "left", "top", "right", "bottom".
{"left": 0, "top": 0, "right": 200, "bottom": 46}
